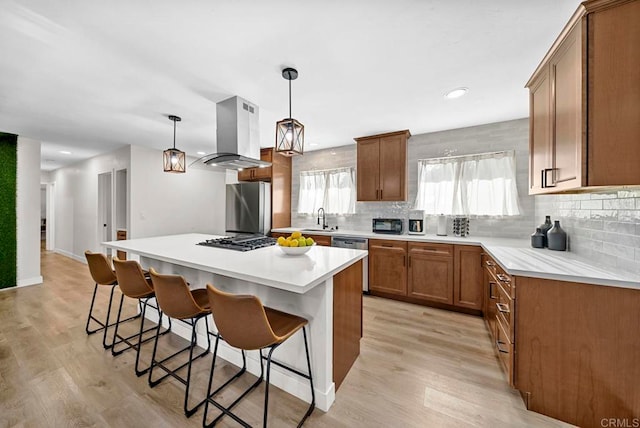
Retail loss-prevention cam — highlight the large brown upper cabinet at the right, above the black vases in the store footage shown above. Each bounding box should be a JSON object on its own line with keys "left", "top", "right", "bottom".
{"left": 526, "top": 0, "right": 640, "bottom": 194}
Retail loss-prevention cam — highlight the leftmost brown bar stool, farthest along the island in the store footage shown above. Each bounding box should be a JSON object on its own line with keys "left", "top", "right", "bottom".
{"left": 84, "top": 250, "right": 140, "bottom": 349}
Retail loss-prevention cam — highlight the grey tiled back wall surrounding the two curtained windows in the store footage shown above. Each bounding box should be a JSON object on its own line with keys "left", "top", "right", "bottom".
{"left": 291, "top": 119, "right": 536, "bottom": 238}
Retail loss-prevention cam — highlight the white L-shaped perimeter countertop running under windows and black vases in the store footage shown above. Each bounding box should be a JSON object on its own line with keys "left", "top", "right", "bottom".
{"left": 273, "top": 228, "right": 640, "bottom": 289}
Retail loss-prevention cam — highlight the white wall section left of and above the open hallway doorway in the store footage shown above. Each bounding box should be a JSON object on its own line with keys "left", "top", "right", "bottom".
{"left": 48, "top": 147, "right": 131, "bottom": 261}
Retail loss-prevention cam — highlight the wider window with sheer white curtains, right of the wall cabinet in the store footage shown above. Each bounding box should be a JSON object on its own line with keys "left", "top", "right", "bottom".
{"left": 415, "top": 151, "right": 520, "bottom": 216}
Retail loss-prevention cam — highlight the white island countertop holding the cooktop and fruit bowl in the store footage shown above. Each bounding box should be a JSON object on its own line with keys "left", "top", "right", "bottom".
{"left": 102, "top": 233, "right": 368, "bottom": 293}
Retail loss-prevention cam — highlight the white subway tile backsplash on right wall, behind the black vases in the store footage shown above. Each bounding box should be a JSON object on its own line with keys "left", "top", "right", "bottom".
{"left": 535, "top": 189, "right": 640, "bottom": 274}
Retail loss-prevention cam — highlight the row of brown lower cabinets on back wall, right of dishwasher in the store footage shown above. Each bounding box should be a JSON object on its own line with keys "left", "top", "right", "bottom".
{"left": 369, "top": 239, "right": 483, "bottom": 314}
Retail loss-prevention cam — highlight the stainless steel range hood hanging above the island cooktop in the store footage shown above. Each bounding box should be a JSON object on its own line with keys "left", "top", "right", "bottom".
{"left": 190, "top": 96, "right": 271, "bottom": 170}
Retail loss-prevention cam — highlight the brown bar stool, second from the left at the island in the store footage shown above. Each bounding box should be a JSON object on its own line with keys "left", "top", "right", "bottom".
{"left": 111, "top": 257, "right": 171, "bottom": 377}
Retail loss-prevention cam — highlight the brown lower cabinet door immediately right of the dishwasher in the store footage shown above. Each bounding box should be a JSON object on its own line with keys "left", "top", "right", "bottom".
{"left": 369, "top": 239, "right": 407, "bottom": 296}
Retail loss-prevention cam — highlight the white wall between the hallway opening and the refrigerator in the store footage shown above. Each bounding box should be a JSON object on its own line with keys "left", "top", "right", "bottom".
{"left": 128, "top": 146, "right": 226, "bottom": 238}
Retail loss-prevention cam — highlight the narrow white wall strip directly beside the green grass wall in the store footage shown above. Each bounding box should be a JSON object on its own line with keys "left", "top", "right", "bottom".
{"left": 16, "top": 137, "right": 42, "bottom": 287}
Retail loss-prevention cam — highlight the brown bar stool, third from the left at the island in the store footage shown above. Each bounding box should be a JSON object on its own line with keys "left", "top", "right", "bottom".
{"left": 149, "top": 268, "right": 246, "bottom": 417}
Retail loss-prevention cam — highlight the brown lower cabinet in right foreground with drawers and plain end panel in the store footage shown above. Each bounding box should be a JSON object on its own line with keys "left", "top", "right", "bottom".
{"left": 483, "top": 255, "right": 640, "bottom": 427}
